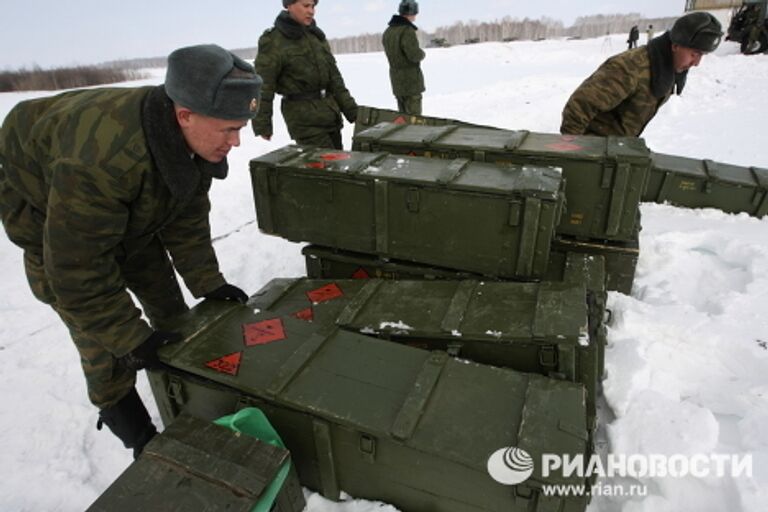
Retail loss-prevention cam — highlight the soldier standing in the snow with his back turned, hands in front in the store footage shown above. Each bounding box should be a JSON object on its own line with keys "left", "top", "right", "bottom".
{"left": 382, "top": 0, "right": 425, "bottom": 115}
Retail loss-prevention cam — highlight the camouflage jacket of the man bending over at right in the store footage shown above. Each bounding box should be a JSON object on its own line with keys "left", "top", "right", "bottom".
{"left": 560, "top": 41, "right": 673, "bottom": 137}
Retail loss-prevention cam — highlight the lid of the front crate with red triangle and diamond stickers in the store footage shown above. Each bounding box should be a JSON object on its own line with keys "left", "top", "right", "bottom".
{"left": 159, "top": 304, "right": 588, "bottom": 482}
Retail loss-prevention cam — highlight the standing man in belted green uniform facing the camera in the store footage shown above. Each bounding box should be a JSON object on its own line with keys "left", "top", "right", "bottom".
{"left": 252, "top": 0, "right": 357, "bottom": 149}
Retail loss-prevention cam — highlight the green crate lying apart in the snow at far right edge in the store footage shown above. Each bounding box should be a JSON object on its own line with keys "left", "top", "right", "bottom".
{"left": 643, "top": 153, "right": 768, "bottom": 217}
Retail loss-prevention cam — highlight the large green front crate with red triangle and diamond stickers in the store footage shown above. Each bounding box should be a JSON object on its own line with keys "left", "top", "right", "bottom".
{"left": 150, "top": 301, "right": 591, "bottom": 512}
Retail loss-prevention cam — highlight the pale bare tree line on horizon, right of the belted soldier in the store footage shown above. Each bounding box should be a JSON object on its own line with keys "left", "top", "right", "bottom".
{"left": 330, "top": 13, "right": 676, "bottom": 54}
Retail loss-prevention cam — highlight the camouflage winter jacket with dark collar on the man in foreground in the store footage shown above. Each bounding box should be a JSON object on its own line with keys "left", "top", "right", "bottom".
{"left": 0, "top": 86, "right": 226, "bottom": 357}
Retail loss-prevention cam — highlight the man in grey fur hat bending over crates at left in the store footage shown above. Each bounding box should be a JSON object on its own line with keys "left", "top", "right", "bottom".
{"left": 0, "top": 45, "right": 261, "bottom": 456}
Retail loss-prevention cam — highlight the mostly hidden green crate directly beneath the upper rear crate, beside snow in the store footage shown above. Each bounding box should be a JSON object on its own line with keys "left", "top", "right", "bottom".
{"left": 552, "top": 234, "right": 640, "bottom": 295}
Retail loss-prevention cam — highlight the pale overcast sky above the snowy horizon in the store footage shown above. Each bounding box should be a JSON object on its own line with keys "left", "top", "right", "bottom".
{"left": 0, "top": 0, "right": 685, "bottom": 69}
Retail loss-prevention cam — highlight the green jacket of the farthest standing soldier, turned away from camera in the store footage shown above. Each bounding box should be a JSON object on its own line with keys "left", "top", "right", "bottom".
{"left": 382, "top": 15, "right": 425, "bottom": 96}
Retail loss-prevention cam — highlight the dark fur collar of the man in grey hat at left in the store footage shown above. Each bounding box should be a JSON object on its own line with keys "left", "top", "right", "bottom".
{"left": 141, "top": 85, "right": 228, "bottom": 202}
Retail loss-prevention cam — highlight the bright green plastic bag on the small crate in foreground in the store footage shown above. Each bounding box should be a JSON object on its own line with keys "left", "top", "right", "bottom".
{"left": 214, "top": 407, "right": 291, "bottom": 512}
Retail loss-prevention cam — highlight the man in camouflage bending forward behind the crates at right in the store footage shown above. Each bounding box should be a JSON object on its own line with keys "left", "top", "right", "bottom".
{"left": 560, "top": 11, "right": 723, "bottom": 137}
